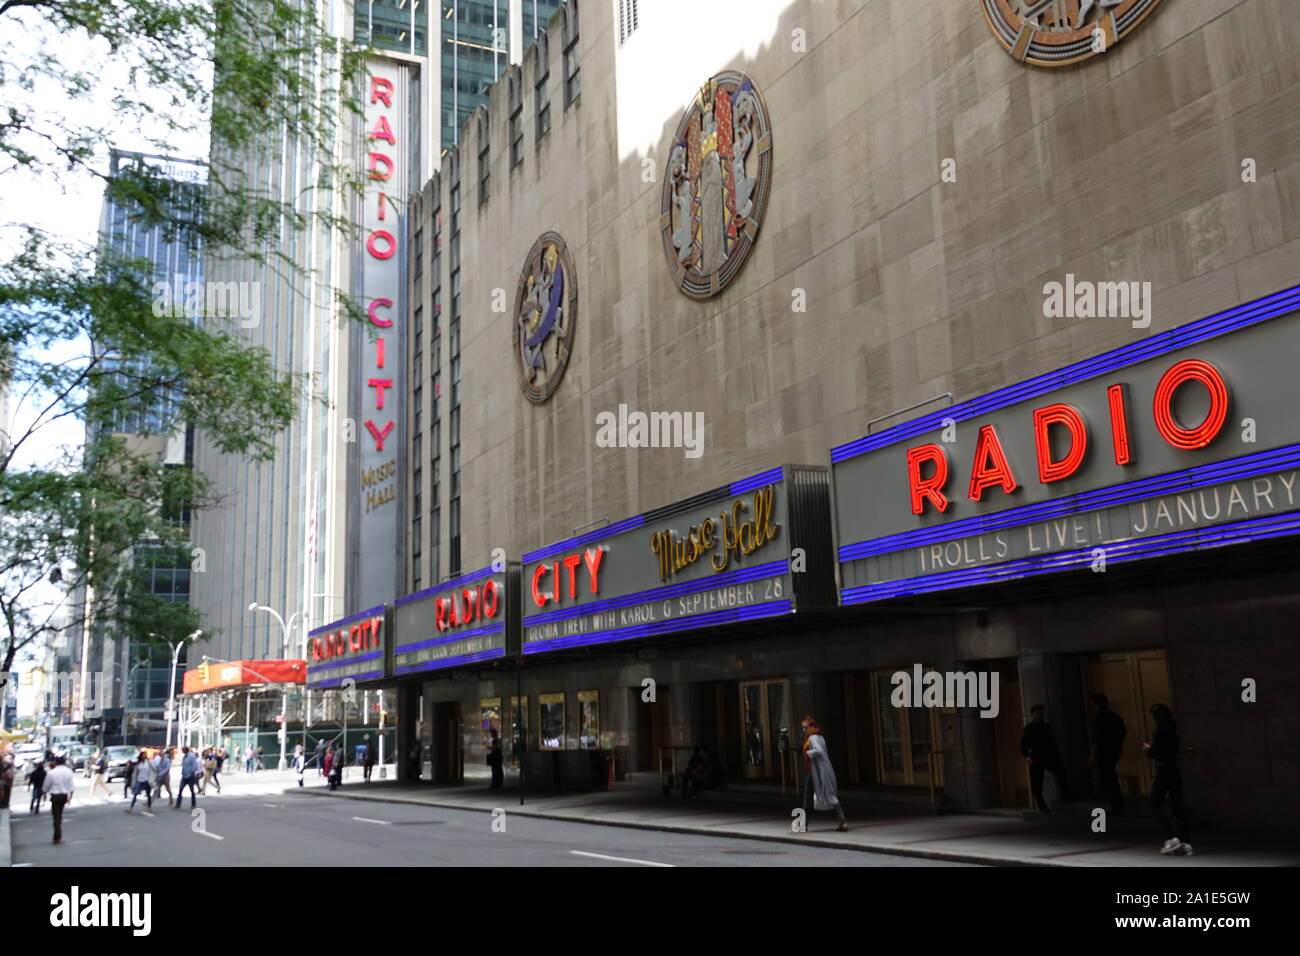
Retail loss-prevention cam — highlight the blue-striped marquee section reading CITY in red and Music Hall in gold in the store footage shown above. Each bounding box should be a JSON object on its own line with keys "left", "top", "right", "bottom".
{"left": 520, "top": 466, "right": 829, "bottom": 654}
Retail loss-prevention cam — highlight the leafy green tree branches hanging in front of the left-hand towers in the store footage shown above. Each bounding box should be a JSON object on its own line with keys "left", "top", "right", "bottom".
{"left": 0, "top": 0, "right": 363, "bottom": 702}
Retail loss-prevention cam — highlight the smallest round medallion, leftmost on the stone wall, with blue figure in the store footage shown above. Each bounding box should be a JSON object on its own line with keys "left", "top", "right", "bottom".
{"left": 515, "top": 233, "right": 577, "bottom": 403}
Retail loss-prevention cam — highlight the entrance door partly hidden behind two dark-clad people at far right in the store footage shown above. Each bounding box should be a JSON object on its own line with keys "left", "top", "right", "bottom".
{"left": 1084, "top": 649, "right": 1174, "bottom": 796}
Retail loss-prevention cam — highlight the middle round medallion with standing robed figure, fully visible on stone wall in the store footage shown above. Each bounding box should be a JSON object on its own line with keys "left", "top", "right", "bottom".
{"left": 659, "top": 70, "right": 772, "bottom": 299}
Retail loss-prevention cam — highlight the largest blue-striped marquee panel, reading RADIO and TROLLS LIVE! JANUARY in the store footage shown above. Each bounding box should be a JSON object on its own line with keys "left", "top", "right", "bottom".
{"left": 831, "top": 286, "right": 1300, "bottom": 604}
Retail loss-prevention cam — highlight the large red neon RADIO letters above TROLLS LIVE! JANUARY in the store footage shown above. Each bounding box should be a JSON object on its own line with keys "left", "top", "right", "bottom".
{"left": 907, "top": 359, "right": 1230, "bottom": 515}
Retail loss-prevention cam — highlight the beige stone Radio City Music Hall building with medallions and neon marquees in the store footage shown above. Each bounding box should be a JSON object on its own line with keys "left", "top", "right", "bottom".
{"left": 309, "top": 0, "right": 1300, "bottom": 830}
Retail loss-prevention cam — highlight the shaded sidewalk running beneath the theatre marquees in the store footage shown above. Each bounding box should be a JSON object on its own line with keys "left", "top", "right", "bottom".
{"left": 295, "top": 775, "right": 1300, "bottom": 866}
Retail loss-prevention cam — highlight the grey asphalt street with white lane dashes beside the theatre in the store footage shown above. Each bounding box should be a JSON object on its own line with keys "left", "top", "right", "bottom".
{"left": 12, "top": 771, "right": 963, "bottom": 868}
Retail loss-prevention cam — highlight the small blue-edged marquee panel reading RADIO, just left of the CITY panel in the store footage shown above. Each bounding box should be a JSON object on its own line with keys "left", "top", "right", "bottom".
{"left": 393, "top": 567, "right": 507, "bottom": 675}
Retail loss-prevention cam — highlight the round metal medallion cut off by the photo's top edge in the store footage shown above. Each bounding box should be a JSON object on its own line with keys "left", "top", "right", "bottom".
{"left": 979, "top": 0, "right": 1160, "bottom": 66}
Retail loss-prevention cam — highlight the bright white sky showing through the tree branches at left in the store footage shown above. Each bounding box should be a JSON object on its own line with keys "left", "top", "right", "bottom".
{"left": 0, "top": 10, "right": 208, "bottom": 714}
